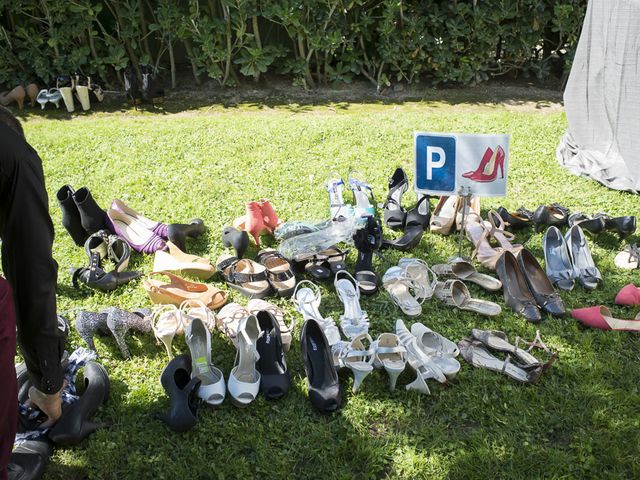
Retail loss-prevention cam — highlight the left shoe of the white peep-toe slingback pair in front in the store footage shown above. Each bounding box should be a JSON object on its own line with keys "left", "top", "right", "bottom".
{"left": 185, "top": 317, "right": 226, "bottom": 405}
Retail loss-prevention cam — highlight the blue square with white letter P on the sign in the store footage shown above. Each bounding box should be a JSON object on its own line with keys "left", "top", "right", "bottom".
{"left": 415, "top": 134, "right": 456, "bottom": 193}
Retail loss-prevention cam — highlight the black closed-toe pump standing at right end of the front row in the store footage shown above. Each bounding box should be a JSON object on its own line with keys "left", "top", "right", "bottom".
{"left": 300, "top": 320, "right": 342, "bottom": 414}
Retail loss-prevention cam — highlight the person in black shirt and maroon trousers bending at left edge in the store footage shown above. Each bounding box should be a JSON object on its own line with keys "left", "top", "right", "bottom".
{"left": 0, "top": 106, "right": 65, "bottom": 480}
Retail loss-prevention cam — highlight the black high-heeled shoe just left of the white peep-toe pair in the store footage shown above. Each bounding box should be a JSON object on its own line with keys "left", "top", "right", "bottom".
{"left": 158, "top": 354, "right": 202, "bottom": 432}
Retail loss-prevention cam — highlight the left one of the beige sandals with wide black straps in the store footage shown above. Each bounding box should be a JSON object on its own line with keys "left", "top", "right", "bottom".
{"left": 216, "top": 254, "right": 271, "bottom": 298}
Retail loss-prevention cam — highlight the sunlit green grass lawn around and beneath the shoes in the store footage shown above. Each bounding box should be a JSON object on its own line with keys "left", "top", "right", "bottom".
{"left": 12, "top": 88, "right": 640, "bottom": 479}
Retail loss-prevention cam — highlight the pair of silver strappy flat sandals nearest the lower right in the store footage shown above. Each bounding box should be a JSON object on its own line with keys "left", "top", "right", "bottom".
{"left": 458, "top": 328, "right": 558, "bottom": 384}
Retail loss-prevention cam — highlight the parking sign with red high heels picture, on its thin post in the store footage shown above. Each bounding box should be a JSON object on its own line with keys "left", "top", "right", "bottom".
{"left": 414, "top": 132, "right": 510, "bottom": 260}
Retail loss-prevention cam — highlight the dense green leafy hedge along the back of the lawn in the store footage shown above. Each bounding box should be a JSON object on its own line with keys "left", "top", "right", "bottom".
{"left": 0, "top": 0, "right": 586, "bottom": 88}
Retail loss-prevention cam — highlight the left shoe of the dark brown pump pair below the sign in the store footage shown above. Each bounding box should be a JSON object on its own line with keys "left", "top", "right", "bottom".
{"left": 496, "top": 251, "right": 542, "bottom": 323}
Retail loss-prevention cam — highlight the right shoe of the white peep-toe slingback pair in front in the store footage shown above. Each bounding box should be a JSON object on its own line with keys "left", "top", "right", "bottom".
{"left": 228, "top": 315, "right": 262, "bottom": 407}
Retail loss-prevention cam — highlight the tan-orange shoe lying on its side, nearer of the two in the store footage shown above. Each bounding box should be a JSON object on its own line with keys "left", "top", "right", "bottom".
{"left": 142, "top": 272, "right": 227, "bottom": 309}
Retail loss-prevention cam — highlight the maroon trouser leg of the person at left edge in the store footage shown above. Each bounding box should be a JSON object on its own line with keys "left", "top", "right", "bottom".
{"left": 0, "top": 277, "right": 18, "bottom": 480}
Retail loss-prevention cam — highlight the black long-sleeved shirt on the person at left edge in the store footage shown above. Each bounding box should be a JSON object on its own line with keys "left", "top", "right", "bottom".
{"left": 0, "top": 123, "right": 65, "bottom": 393}
